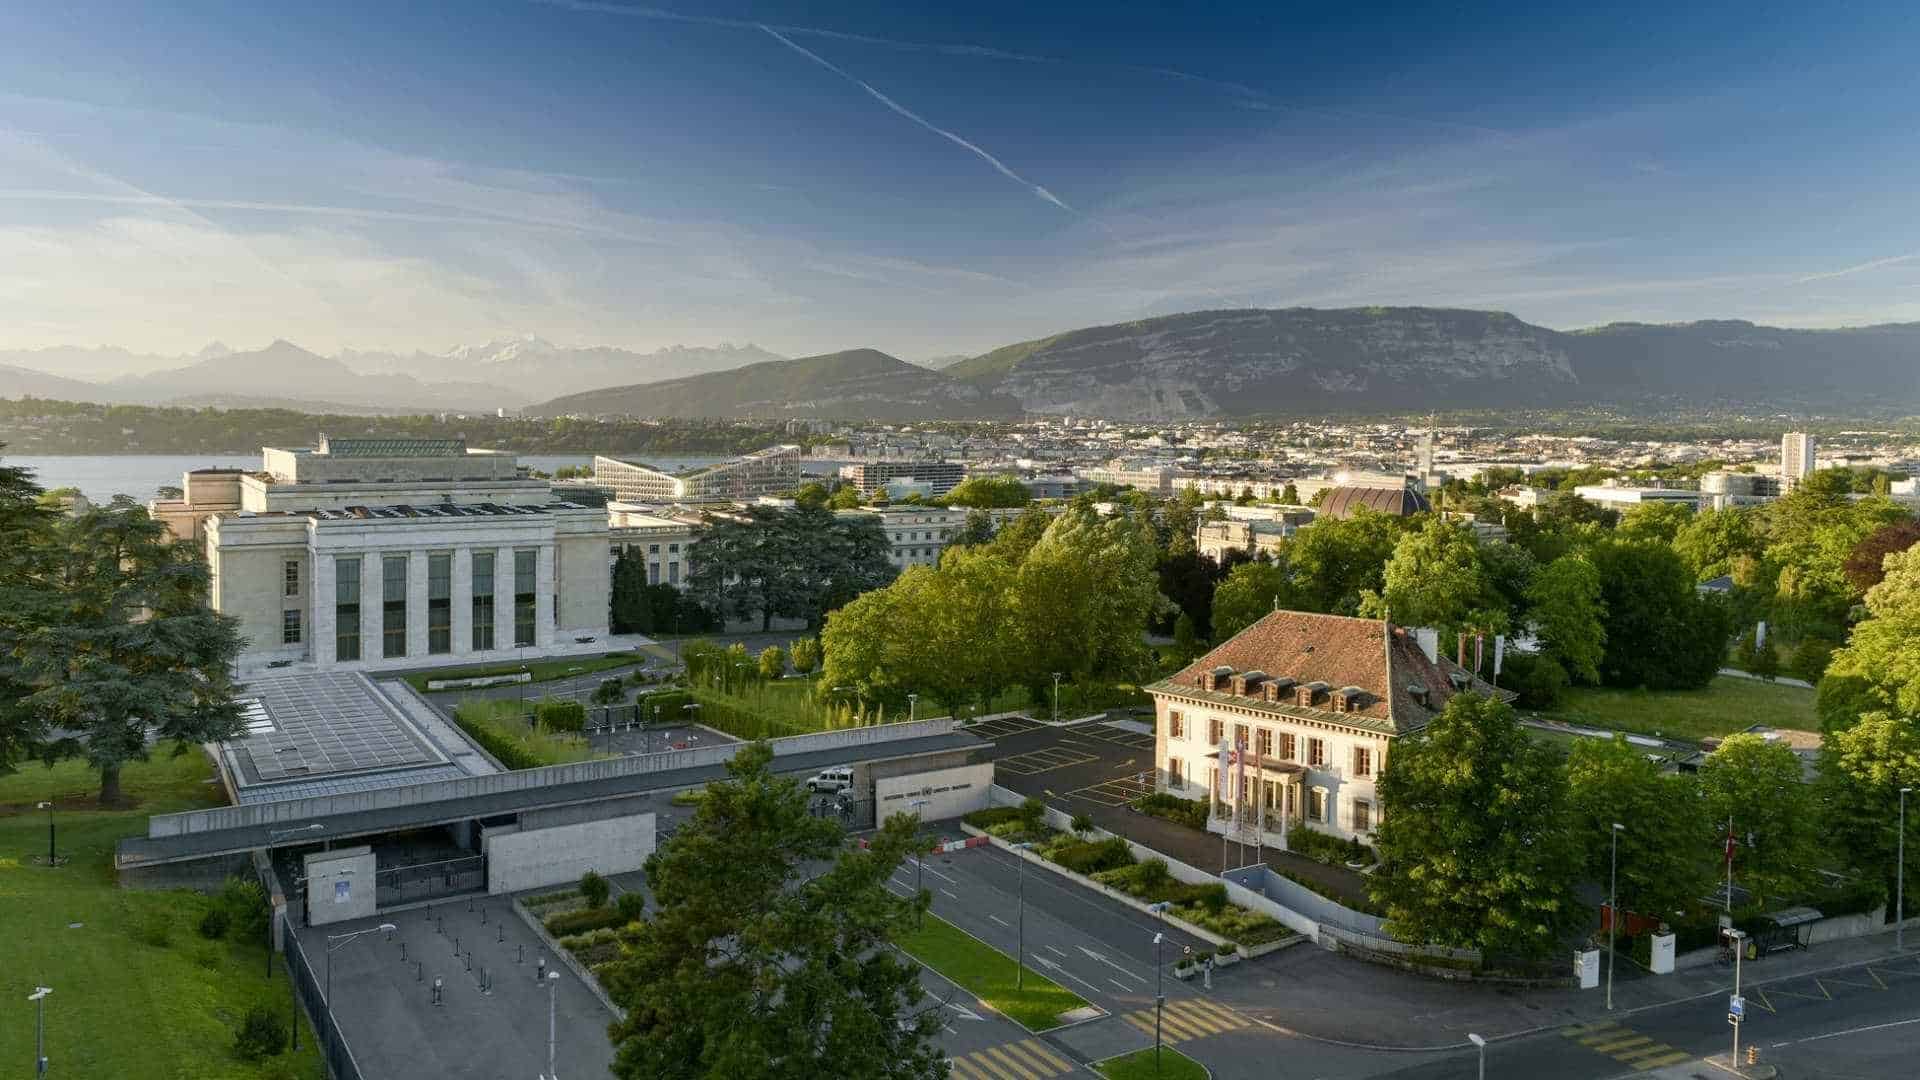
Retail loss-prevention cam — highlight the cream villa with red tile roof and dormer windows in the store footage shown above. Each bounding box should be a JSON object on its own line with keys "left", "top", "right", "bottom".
{"left": 1144, "top": 611, "right": 1513, "bottom": 847}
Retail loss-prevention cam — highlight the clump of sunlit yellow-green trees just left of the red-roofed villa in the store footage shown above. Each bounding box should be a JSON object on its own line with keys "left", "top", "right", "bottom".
{"left": 822, "top": 503, "right": 1160, "bottom": 709}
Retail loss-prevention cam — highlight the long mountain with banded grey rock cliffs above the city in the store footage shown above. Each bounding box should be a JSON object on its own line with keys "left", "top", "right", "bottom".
{"left": 947, "top": 307, "right": 1576, "bottom": 419}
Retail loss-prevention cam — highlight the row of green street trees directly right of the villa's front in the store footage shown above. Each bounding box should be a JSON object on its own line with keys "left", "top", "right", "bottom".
{"left": 1373, "top": 694, "right": 1835, "bottom": 957}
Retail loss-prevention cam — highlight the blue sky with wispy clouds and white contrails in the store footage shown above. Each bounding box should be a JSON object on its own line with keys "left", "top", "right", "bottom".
{"left": 0, "top": 0, "right": 1920, "bottom": 359}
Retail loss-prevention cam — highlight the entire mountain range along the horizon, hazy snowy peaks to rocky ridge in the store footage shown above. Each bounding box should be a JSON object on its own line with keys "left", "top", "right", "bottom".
{"left": 0, "top": 307, "right": 1920, "bottom": 421}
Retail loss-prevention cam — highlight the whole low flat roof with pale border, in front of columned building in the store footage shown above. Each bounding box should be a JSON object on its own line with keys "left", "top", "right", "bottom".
{"left": 221, "top": 673, "right": 449, "bottom": 803}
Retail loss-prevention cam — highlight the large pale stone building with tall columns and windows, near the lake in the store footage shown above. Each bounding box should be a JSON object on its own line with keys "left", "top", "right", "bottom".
{"left": 168, "top": 438, "right": 609, "bottom": 671}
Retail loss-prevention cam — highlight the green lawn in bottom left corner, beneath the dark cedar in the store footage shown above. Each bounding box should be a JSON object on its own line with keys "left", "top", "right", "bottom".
{"left": 0, "top": 751, "right": 323, "bottom": 1080}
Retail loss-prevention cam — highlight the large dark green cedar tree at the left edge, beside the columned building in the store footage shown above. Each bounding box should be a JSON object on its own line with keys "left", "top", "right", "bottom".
{"left": 0, "top": 447, "right": 244, "bottom": 805}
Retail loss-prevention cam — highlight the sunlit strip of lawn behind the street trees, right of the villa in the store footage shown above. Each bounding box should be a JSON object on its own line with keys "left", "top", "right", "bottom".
{"left": 1542, "top": 675, "right": 1820, "bottom": 740}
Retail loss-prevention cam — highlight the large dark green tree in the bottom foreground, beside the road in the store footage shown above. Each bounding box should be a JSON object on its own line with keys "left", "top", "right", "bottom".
{"left": 605, "top": 744, "right": 947, "bottom": 1080}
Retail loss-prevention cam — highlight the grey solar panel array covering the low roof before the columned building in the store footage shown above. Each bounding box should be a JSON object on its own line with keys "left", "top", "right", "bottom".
{"left": 230, "top": 673, "right": 445, "bottom": 784}
